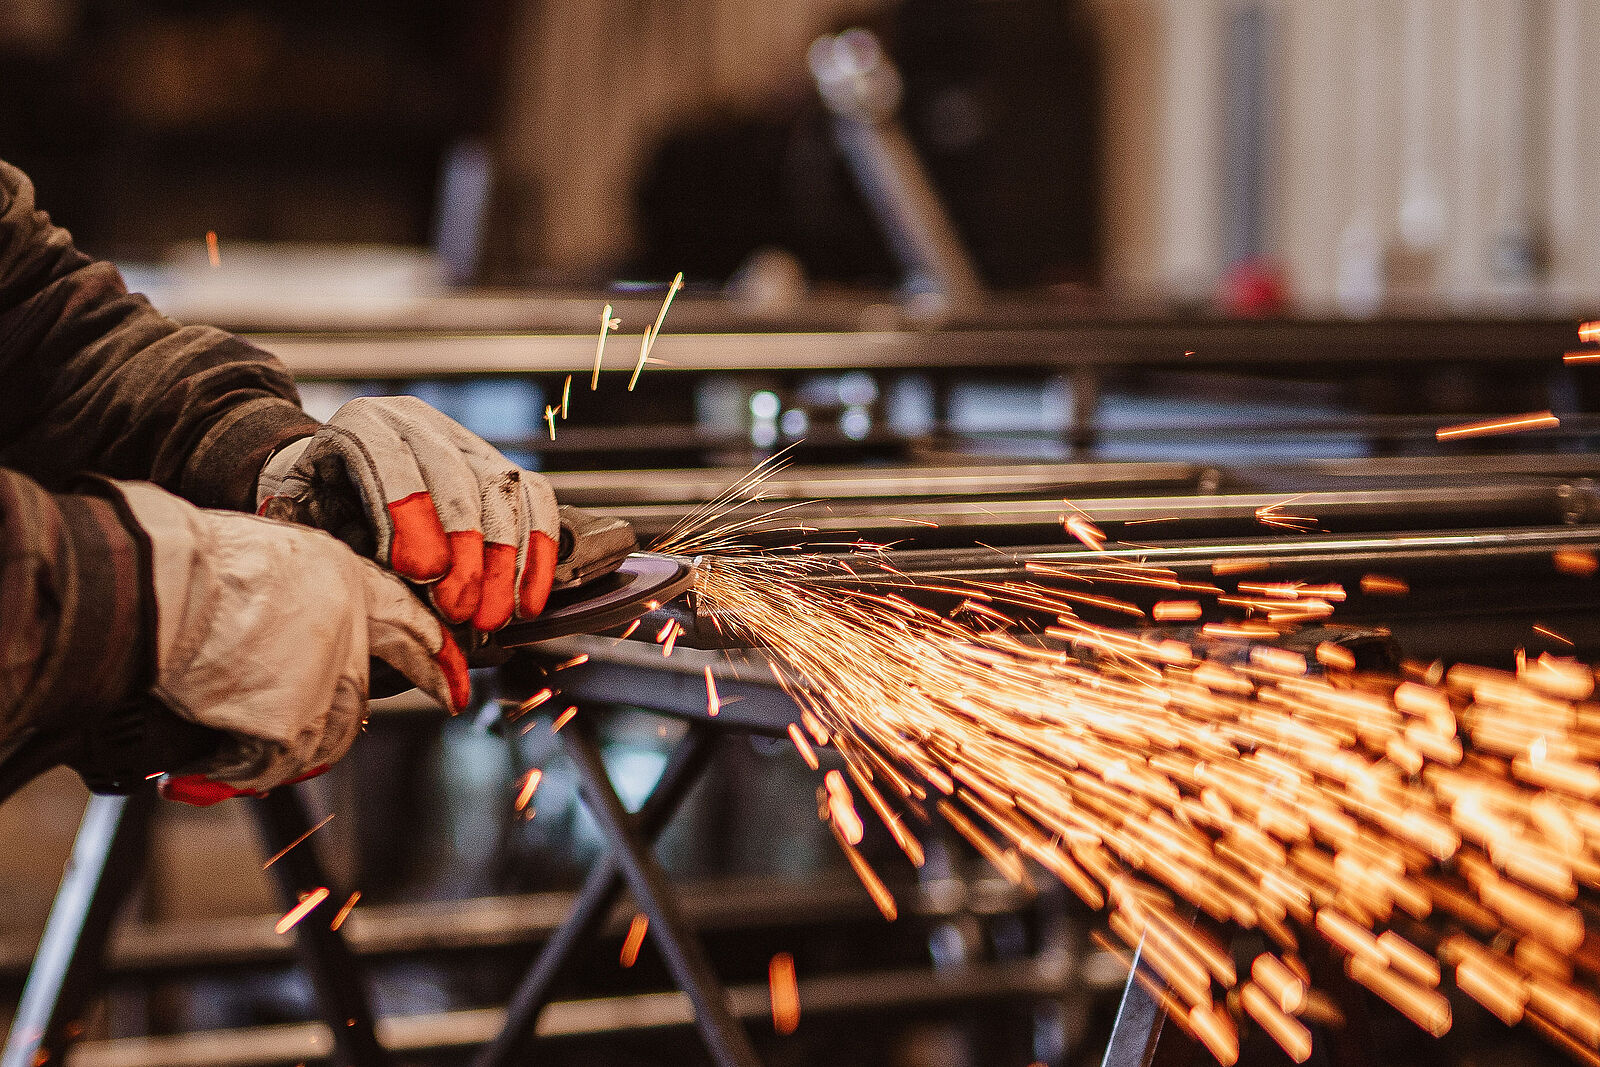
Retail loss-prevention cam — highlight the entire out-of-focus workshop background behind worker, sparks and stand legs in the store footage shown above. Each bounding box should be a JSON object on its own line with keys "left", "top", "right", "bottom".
{"left": 0, "top": 0, "right": 1600, "bottom": 1067}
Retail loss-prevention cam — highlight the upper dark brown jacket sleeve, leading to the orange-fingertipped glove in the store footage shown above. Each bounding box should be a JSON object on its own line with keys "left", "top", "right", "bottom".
{"left": 0, "top": 162, "right": 318, "bottom": 510}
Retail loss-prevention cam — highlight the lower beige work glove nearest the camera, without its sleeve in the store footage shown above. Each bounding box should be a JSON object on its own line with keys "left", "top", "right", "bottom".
{"left": 112, "top": 482, "right": 470, "bottom": 803}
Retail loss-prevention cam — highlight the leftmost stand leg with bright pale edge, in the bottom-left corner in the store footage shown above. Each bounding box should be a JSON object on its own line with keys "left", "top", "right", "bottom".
{"left": 0, "top": 789, "right": 155, "bottom": 1067}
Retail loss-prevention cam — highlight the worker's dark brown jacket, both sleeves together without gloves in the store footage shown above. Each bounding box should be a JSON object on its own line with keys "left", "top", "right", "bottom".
{"left": 0, "top": 162, "right": 317, "bottom": 742}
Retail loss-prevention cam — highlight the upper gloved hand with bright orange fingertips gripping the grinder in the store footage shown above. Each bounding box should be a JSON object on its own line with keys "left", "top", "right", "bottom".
{"left": 256, "top": 397, "right": 560, "bottom": 630}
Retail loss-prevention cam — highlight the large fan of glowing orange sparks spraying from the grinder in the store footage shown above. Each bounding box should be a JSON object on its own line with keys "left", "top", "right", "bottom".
{"left": 643, "top": 457, "right": 1600, "bottom": 1064}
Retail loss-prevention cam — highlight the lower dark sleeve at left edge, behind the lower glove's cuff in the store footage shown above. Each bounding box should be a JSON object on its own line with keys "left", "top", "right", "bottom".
{"left": 0, "top": 469, "right": 155, "bottom": 742}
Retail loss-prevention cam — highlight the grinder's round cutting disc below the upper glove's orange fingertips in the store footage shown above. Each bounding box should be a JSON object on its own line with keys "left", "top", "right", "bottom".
{"left": 493, "top": 552, "right": 694, "bottom": 649}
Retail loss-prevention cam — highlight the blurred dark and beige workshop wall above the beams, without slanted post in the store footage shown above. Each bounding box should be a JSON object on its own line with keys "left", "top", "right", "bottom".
{"left": 0, "top": 0, "right": 1600, "bottom": 315}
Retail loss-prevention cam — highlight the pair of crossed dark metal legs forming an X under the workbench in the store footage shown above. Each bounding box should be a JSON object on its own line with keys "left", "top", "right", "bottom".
{"left": 474, "top": 723, "right": 758, "bottom": 1067}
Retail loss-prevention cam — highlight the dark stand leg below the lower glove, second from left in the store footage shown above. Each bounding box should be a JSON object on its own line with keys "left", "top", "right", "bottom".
{"left": 251, "top": 787, "right": 387, "bottom": 1067}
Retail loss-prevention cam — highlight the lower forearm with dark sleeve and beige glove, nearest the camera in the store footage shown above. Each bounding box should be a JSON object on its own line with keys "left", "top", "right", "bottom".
{"left": 0, "top": 469, "right": 469, "bottom": 800}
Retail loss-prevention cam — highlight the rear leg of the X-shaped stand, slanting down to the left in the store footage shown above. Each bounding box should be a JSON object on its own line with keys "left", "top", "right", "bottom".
{"left": 472, "top": 725, "right": 718, "bottom": 1067}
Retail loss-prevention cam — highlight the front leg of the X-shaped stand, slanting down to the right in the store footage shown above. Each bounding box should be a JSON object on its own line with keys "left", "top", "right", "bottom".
{"left": 560, "top": 720, "right": 760, "bottom": 1067}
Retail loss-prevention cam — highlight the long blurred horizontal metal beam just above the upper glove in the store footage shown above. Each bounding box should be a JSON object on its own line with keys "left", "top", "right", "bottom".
{"left": 250, "top": 316, "right": 1573, "bottom": 381}
